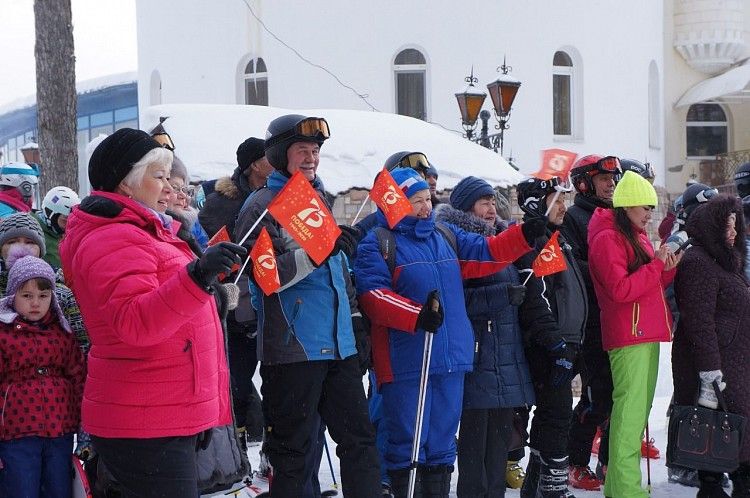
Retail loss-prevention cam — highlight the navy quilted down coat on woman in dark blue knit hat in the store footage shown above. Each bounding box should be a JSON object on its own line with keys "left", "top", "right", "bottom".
{"left": 435, "top": 204, "right": 535, "bottom": 409}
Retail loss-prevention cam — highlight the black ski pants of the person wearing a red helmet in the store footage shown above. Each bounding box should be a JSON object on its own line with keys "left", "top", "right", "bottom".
{"left": 568, "top": 331, "right": 613, "bottom": 466}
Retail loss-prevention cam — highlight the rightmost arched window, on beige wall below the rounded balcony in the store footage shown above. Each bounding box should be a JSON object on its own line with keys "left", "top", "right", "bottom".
{"left": 686, "top": 104, "right": 729, "bottom": 159}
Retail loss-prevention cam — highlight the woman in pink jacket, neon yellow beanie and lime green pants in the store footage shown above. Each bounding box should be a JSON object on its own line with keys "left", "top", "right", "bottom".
{"left": 588, "top": 171, "right": 680, "bottom": 498}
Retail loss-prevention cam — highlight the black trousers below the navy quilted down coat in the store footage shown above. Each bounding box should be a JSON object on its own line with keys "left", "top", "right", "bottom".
{"left": 456, "top": 408, "right": 515, "bottom": 498}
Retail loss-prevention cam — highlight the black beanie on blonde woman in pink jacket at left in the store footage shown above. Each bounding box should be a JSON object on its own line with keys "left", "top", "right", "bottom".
{"left": 89, "top": 128, "right": 161, "bottom": 192}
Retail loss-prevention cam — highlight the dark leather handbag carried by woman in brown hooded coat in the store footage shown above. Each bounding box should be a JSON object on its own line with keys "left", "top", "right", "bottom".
{"left": 667, "top": 381, "right": 747, "bottom": 473}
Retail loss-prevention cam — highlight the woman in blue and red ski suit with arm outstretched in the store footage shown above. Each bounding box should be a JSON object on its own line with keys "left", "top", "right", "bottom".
{"left": 354, "top": 168, "right": 546, "bottom": 498}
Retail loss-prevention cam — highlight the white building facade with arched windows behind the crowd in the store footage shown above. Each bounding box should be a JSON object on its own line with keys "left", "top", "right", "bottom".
{"left": 137, "top": 0, "right": 750, "bottom": 192}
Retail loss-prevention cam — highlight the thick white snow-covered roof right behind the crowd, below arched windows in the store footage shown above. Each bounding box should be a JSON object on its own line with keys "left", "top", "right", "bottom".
{"left": 140, "top": 104, "right": 522, "bottom": 194}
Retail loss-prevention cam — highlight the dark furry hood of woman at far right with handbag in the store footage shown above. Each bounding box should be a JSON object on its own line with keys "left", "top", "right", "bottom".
{"left": 686, "top": 194, "right": 746, "bottom": 273}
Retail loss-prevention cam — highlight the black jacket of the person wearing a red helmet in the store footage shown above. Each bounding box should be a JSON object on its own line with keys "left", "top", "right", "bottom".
{"left": 560, "top": 194, "right": 611, "bottom": 340}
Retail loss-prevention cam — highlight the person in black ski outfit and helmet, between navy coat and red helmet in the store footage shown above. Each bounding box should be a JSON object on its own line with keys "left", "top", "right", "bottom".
{"left": 516, "top": 177, "right": 588, "bottom": 498}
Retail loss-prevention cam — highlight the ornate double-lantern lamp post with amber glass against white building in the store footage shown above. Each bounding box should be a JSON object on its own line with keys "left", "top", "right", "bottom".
{"left": 456, "top": 58, "right": 521, "bottom": 159}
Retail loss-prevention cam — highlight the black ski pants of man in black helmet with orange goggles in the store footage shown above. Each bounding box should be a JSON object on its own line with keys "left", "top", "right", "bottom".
{"left": 260, "top": 355, "right": 381, "bottom": 498}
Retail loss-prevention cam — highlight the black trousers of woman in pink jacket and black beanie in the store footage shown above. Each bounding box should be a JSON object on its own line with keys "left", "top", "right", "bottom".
{"left": 91, "top": 436, "right": 199, "bottom": 498}
